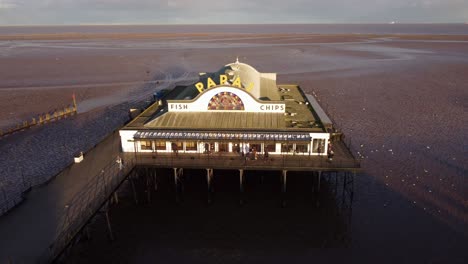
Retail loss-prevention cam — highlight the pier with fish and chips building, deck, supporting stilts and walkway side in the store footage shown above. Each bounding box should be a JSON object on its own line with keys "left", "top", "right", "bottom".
{"left": 45, "top": 61, "right": 361, "bottom": 260}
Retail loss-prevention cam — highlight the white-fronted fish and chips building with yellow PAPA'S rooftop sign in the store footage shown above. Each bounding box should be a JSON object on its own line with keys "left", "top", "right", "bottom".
{"left": 120, "top": 61, "right": 332, "bottom": 158}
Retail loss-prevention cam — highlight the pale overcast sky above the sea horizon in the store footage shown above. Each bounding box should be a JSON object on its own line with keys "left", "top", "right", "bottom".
{"left": 0, "top": 0, "right": 468, "bottom": 25}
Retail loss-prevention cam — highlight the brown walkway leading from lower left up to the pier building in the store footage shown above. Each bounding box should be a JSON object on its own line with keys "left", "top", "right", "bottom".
{"left": 0, "top": 132, "right": 120, "bottom": 263}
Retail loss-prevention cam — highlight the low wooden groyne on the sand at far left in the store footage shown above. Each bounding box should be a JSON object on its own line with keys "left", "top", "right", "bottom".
{"left": 0, "top": 95, "right": 77, "bottom": 138}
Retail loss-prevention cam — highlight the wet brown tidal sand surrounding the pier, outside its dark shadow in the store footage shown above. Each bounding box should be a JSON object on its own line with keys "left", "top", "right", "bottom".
{"left": 0, "top": 34, "right": 468, "bottom": 263}
